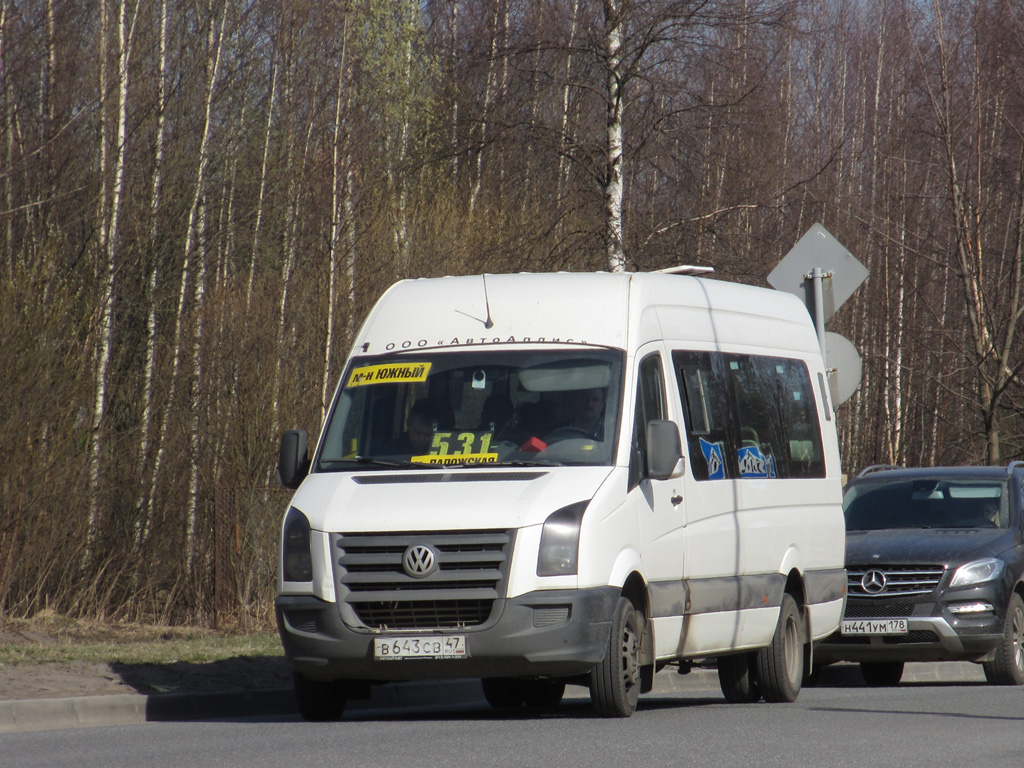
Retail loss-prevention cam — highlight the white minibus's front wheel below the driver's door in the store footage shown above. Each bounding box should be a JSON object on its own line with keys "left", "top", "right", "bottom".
{"left": 590, "top": 597, "right": 644, "bottom": 718}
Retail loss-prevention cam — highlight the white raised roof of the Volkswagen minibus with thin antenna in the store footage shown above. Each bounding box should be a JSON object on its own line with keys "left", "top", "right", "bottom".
{"left": 353, "top": 272, "right": 818, "bottom": 354}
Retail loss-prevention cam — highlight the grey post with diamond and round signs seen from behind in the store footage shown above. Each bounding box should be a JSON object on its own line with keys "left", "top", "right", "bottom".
{"left": 768, "top": 224, "right": 867, "bottom": 407}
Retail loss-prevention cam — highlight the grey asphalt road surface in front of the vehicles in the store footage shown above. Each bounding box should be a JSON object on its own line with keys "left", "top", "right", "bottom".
{"left": 0, "top": 672, "right": 1024, "bottom": 768}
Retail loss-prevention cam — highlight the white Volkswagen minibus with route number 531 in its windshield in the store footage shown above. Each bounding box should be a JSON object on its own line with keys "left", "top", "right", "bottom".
{"left": 275, "top": 268, "right": 846, "bottom": 720}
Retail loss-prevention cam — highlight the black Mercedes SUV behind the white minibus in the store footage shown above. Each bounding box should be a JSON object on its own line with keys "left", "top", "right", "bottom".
{"left": 814, "top": 462, "right": 1024, "bottom": 685}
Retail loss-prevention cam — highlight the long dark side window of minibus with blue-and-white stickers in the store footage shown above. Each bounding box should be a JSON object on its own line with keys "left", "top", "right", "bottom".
{"left": 673, "top": 351, "right": 825, "bottom": 480}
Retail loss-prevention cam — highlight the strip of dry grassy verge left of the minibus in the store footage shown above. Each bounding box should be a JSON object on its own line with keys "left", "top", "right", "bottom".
{"left": 0, "top": 611, "right": 282, "bottom": 665}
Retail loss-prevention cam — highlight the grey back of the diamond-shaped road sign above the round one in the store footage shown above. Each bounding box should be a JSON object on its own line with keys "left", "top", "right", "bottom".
{"left": 768, "top": 224, "right": 867, "bottom": 319}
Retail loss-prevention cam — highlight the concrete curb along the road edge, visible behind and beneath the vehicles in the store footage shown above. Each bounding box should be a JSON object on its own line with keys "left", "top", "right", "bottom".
{"left": 0, "top": 663, "right": 985, "bottom": 733}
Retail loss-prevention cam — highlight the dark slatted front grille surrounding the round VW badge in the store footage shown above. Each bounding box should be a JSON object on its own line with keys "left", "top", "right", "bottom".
{"left": 331, "top": 530, "right": 513, "bottom": 630}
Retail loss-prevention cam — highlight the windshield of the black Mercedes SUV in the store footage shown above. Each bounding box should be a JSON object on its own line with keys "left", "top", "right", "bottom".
{"left": 843, "top": 478, "right": 1010, "bottom": 530}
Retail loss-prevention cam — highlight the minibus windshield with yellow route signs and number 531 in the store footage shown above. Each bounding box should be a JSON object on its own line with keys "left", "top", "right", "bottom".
{"left": 315, "top": 349, "right": 623, "bottom": 471}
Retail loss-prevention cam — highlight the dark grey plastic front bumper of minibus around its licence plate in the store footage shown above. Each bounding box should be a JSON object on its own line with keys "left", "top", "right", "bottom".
{"left": 274, "top": 587, "right": 620, "bottom": 682}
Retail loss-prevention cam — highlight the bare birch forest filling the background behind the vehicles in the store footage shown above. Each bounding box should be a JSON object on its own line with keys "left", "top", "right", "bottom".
{"left": 0, "top": 0, "right": 1024, "bottom": 629}
